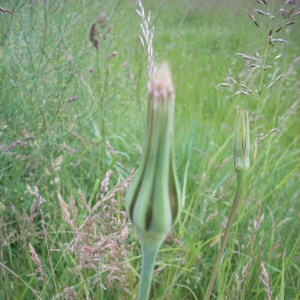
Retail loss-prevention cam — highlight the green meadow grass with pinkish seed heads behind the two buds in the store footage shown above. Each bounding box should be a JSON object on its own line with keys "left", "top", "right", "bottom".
{"left": 0, "top": 0, "right": 300, "bottom": 300}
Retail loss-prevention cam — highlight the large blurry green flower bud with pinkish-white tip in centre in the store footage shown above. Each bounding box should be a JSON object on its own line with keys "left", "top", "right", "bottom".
{"left": 126, "top": 64, "right": 181, "bottom": 242}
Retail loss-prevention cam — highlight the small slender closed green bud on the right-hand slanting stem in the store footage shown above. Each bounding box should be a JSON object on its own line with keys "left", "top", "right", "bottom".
{"left": 233, "top": 108, "right": 250, "bottom": 171}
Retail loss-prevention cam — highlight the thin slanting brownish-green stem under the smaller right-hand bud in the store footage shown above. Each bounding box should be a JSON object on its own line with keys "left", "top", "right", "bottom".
{"left": 204, "top": 171, "right": 246, "bottom": 300}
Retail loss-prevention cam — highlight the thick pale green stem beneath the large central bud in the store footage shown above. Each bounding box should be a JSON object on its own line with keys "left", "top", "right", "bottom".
{"left": 137, "top": 241, "right": 162, "bottom": 300}
